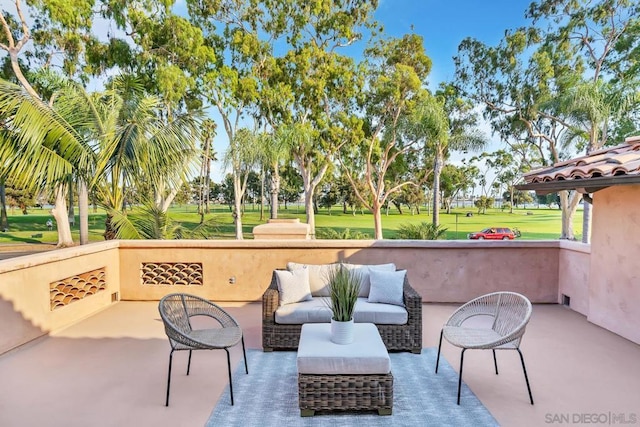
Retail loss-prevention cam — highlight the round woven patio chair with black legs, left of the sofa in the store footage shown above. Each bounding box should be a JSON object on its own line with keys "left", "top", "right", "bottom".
{"left": 158, "top": 294, "right": 249, "bottom": 406}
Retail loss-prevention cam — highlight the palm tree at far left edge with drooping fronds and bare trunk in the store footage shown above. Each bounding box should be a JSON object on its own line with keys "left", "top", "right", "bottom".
{"left": 0, "top": 79, "right": 94, "bottom": 247}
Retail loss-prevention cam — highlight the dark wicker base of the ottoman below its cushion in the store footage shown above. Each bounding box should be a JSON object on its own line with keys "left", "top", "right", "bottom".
{"left": 298, "top": 374, "right": 393, "bottom": 411}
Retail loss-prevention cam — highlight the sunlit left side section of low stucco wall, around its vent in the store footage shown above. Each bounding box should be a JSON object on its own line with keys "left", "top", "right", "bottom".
{"left": 0, "top": 242, "right": 119, "bottom": 354}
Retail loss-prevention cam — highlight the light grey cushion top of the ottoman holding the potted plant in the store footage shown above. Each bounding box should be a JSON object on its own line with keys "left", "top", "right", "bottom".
{"left": 297, "top": 323, "right": 391, "bottom": 375}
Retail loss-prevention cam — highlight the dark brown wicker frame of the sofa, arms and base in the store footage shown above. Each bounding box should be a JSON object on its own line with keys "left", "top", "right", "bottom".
{"left": 262, "top": 263, "right": 422, "bottom": 354}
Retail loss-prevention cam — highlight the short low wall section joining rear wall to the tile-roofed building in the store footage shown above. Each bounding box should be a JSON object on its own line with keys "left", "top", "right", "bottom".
{"left": 558, "top": 240, "right": 591, "bottom": 316}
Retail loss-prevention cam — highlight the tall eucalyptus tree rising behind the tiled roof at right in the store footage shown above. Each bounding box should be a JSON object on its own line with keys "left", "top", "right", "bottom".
{"left": 456, "top": 0, "right": 640, "bottom": 239}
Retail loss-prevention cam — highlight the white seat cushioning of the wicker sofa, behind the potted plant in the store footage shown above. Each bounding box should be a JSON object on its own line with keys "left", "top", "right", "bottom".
{"left": 275, "top": 297, "right": 409, "bottom": 325}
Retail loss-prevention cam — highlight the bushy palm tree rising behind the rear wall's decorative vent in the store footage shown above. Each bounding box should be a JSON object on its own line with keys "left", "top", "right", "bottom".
{"left": 91, "top": 77, "right": 201, "bottom": 240}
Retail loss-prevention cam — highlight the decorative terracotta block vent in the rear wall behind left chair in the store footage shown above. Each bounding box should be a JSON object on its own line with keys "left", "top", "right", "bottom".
{"left": 141, "top": 262, "right": 203, "bottom": 286}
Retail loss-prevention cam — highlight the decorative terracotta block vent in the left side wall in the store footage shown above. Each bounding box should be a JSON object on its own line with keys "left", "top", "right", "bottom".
{"left": 49, "top": 267, "right": 107, "bottom": 311}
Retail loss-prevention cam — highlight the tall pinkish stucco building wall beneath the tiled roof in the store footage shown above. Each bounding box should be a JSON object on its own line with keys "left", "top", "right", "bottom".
{"left": 588, "top": 185, "right": 640, "bottom": 343}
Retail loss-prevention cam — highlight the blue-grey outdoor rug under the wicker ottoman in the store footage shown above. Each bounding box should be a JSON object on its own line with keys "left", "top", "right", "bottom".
{"left": 206, "top": 348, "right": 498, "bottom": 427}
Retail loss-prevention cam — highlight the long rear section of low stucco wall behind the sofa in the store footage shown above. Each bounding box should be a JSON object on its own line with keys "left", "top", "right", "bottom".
{"left": 120, "top": 240, "right": 559, "bottom": 303}
